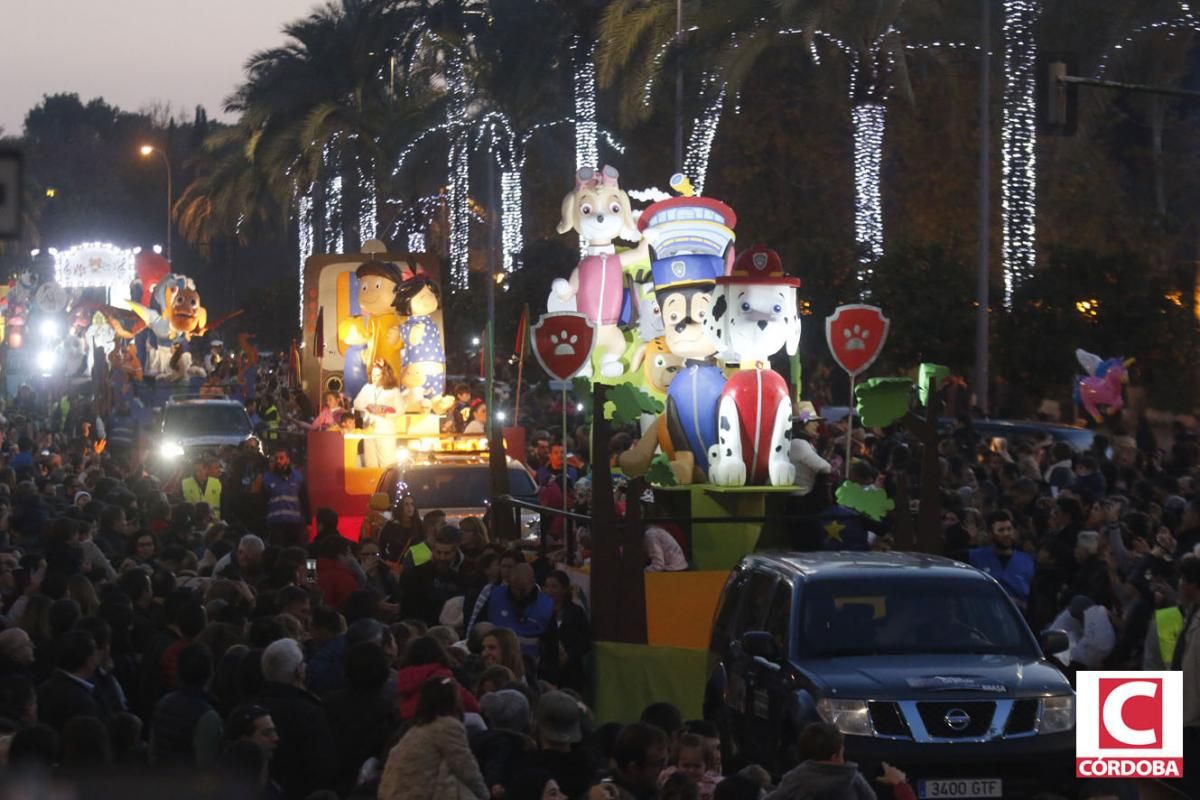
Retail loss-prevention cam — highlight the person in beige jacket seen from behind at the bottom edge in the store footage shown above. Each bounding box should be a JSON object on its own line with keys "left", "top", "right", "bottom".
{"left": 378, "top": 676, "right": 491, "bottom": 800}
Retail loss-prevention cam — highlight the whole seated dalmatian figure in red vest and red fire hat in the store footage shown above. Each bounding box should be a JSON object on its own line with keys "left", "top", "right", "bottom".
{"left": 707, "top": 246, "right": 800, "bottom": 486}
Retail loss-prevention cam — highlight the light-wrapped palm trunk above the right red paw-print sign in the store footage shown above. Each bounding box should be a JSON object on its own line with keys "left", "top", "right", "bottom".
{"left": 851, "top": 101, "right": 887, "bottom": 287}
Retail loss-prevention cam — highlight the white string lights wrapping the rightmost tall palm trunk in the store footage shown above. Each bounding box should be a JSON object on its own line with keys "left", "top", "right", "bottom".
{"left": 1001, "top": 0, "right": 1038, "bottom": 309}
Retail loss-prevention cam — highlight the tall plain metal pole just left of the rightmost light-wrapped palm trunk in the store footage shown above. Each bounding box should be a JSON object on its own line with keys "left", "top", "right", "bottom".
{"left": 974, "top": 0, "right": 992, "bottom": 416}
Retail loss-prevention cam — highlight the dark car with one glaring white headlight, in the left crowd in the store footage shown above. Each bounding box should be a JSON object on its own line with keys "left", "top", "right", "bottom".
{"left": 152, "top": 397, "right": 254, "bottom": 467}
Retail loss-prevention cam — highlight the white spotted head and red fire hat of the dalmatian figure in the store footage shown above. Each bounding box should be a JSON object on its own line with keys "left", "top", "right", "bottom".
{"left": 706, "top": 245, "right": 800, "bottom": 369}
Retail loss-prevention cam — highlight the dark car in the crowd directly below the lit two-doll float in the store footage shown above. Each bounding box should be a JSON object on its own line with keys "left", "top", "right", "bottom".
{"left": 376, "top": 453, "right": 540, "bottom": 541}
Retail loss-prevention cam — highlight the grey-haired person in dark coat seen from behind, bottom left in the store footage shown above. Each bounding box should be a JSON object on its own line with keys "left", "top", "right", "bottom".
{"left": 256, "top": 639, "right": 338, "bottom": 800}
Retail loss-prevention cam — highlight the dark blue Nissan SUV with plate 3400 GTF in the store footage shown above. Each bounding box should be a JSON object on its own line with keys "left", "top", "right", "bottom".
{"left": 704, "top": 552, "right": 1075, "bottom": 798}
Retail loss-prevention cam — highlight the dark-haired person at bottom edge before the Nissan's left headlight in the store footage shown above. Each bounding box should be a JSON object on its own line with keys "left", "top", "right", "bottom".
{"left": 766, "top": 722, "right": 917, "bottom": 800}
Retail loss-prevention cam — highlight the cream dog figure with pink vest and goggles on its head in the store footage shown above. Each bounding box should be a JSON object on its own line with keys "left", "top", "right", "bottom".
{"left": 547, "top": 167, "right": 649, "bottom": 378}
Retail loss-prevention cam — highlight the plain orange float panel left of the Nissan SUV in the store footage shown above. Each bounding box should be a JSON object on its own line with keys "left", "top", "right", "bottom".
{"left": 646, "top": 571, "right": 730, "bottom": 650}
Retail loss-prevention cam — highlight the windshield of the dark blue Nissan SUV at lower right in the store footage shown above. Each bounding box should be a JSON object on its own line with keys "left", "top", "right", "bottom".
{"left": 798, "top": 576, "right": 1037, "bottom": 657}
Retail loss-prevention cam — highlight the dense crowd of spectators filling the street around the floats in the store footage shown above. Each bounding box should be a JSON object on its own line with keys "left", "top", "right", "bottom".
{"left": 0, "top": 364, "right": 1200, "bottom": 800}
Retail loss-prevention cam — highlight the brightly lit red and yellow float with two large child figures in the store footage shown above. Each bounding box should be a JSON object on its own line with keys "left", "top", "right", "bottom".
{"left": 300, "top": 241, "right": 506, "bottom": 540}
